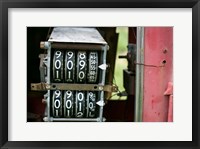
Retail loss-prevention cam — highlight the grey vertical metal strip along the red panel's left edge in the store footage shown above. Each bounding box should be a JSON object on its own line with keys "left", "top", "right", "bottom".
{"left": 134, "top": 27, "right": 144, "bottom": 122}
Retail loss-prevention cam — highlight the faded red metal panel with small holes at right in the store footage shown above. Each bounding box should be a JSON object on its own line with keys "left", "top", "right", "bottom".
{"left": 143, "top": 27, "right": 173, "bottom": 122}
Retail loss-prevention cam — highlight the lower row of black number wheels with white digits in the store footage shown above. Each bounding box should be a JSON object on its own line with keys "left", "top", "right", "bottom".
{"left": 51, "top": 90, "right": 97, "bottom": 118}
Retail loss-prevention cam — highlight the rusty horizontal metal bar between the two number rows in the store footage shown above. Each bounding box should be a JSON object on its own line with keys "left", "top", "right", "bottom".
{"left": 31, "top": 83, "right": 118, "bottom": 92}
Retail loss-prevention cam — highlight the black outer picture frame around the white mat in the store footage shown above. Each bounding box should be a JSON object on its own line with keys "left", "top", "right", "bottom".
{"left": 0, "top": 0, "right": 200, "bottom": 149}
